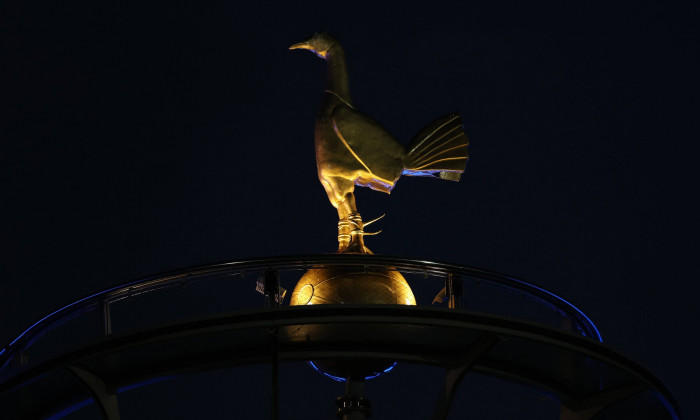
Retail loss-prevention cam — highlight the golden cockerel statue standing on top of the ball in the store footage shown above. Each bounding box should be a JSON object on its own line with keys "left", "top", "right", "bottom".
{"left": 289, "top": 33, "right": 469, "bottom": 254}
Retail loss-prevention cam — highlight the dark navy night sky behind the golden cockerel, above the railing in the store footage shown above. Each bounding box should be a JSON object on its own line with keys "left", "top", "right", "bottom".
{"left": 0, "top": 2, "right": 700, "bottom": 418}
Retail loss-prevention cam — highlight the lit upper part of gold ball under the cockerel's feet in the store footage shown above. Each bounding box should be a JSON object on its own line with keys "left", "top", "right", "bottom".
{"left": 289, "top": 267, "right": 416, "bottom": 306}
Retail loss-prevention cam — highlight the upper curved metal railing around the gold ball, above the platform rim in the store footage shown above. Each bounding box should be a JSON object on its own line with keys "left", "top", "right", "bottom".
{"left": 0, "top": 254, "right": 602, "bottom": 377}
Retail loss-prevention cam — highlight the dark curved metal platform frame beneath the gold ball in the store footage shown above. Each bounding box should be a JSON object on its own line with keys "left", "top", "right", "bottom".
{"left": 0, "top": 294, "right": 680, "bottom": 420}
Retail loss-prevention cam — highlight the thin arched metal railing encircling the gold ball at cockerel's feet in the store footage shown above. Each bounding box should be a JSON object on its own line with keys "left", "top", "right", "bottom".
{"left": 0, "top": 254, "right": 602, "bottom": 374}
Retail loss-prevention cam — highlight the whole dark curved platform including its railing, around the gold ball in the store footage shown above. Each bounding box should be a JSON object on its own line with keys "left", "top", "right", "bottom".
{"left": 0, "top": 254, "right": 679, "bottom": 420}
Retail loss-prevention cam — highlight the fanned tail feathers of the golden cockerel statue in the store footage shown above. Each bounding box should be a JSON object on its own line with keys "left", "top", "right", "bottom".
{"left": 403, "top": 113, "right": 469, "bottom": 181}
